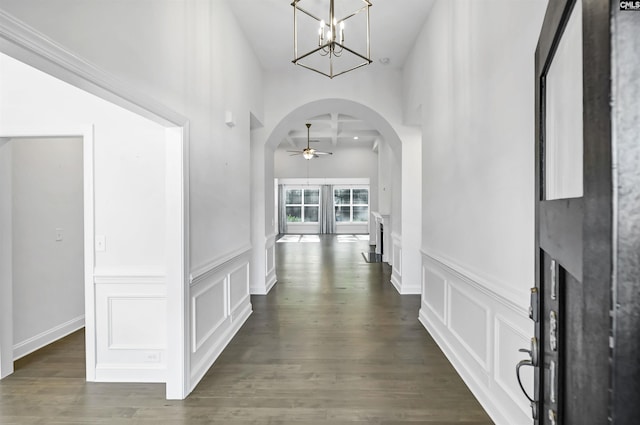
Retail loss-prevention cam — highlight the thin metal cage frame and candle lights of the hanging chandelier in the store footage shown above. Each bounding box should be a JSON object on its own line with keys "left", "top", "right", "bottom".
{"left": 291, "top": 0, "right": 373, "bottom": 78}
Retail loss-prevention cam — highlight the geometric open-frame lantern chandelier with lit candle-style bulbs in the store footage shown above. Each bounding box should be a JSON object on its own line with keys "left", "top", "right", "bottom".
{"left": 291, "top": 0, "right": 372, "bottom": 78}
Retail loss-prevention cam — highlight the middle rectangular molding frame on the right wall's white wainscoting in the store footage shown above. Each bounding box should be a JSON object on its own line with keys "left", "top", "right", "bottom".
{"left": 446, "top": 282, "right": 492, "bottom": 373}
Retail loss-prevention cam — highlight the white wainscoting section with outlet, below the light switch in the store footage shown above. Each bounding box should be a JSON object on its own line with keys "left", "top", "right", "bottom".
{"left": 94, "top": 270, "right": 167, "bottom": 382}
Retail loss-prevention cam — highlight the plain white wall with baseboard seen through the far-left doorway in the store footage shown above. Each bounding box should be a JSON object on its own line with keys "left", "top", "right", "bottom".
{"left": 11, "top": 138, "right": 84, "bottom": 358}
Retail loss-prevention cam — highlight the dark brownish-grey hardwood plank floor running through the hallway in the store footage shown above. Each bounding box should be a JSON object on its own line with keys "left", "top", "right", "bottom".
{"left": 0, "top": 236, "right": 492, "bottom": 425}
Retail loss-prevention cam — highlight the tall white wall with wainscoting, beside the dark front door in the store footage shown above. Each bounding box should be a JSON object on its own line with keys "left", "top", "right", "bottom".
{"left": 403, "top": 0, "right": 546, "bottom": 425}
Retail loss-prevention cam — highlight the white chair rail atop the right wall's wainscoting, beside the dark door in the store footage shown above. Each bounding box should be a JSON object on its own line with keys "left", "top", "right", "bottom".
{"left": 421, "top": 250, "right": 533, "bottom": 315}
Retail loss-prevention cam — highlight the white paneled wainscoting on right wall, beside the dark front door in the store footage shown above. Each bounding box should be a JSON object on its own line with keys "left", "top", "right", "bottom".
{"left": 419, "top": 252, "right": 533, "bottom": 425}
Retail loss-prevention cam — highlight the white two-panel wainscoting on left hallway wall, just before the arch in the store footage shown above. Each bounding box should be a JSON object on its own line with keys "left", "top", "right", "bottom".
{"left": 189, "top": 249, "right": 251, "bottom": 391}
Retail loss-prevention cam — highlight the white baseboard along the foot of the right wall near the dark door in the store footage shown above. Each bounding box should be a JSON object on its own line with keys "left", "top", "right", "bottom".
{"left": 418, "top": 309, "right": 512, "bottom": 425}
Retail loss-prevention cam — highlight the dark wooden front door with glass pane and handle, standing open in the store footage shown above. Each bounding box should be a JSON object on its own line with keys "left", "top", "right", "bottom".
{"left": 531, "top": 0, "right": 640, "bottom": 425}
